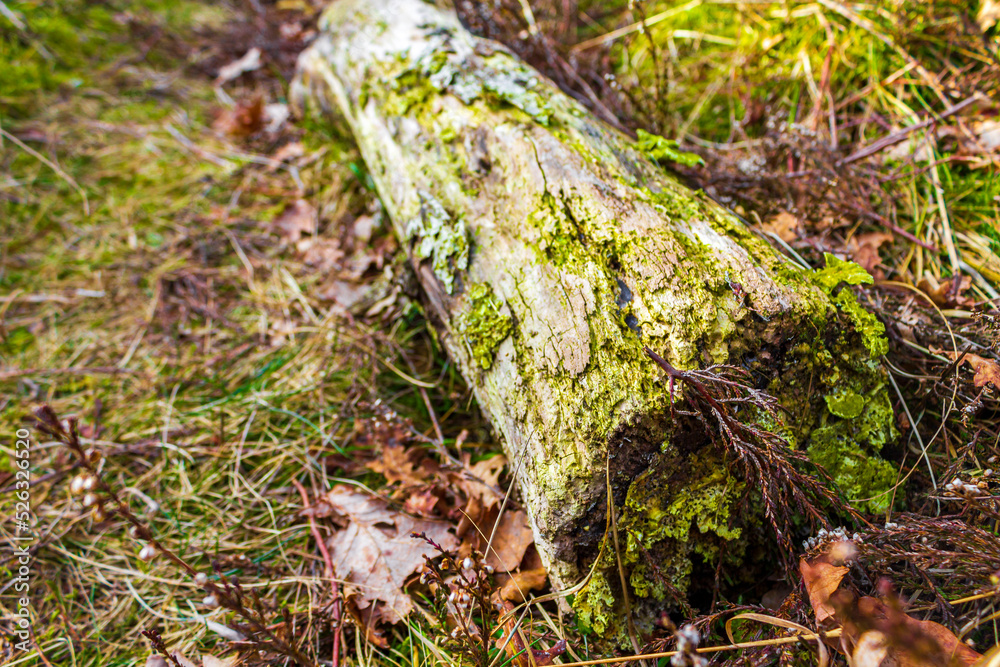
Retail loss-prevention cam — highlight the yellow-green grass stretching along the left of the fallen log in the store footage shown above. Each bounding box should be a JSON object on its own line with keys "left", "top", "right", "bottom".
{"left": 0, "top": 2, "right": 481, "bottom": 665}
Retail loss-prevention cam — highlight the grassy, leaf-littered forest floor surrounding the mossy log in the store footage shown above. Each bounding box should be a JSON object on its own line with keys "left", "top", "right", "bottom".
{"left": 0, "top": 0, "right": 1000, "bottom": 666}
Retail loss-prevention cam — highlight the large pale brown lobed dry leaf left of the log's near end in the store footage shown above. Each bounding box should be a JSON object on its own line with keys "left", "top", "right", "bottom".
{"left": 322, "top": 484, "right": 458, "bottom": 623}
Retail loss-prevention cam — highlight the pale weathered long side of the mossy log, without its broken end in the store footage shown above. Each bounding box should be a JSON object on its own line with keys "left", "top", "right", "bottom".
{"left": 295, "top": 0, "right": 896, "bottom": 620}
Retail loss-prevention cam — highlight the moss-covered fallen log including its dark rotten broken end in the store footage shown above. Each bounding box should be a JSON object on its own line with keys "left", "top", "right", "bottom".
{"left": 293, "top": 0, "right": 894, "bottom": 631}
